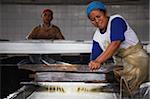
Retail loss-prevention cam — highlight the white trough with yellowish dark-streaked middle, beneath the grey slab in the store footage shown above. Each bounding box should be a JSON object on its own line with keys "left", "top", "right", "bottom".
{"left": 6, "top": 82, "right": 119, "bottom": 99}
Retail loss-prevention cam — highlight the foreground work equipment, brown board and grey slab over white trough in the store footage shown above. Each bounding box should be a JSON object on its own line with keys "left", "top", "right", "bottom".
{"left": 7, "top": 64, "right": 119, "bottom": 99}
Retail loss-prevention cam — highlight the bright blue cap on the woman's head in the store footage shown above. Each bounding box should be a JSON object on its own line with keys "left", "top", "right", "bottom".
{"left": 86, "top": 1, "right": 106, "bottom": 16}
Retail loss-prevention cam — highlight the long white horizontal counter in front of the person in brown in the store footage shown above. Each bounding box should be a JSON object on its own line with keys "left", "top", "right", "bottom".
{"left": 0, "top": 40, "right": 91, "bottom": 54}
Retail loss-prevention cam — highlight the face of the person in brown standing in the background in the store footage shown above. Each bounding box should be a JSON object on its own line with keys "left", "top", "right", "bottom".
{"left": 42, "top": 11, "right": 53, "bottom": 24}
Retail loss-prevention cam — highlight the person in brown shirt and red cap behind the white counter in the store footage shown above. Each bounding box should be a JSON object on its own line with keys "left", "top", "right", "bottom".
{"left": 26, "top": 9, "right": 64, "bottom": 40}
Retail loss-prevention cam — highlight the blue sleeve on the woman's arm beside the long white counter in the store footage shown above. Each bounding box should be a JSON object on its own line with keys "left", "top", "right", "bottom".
{"left": 90, "top": 40, "right": 103, "bottom": 60}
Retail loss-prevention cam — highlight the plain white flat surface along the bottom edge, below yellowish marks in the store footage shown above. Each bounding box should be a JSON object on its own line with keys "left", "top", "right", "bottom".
{"left": 27, "top": 92, "right": 119, "bottom": 99}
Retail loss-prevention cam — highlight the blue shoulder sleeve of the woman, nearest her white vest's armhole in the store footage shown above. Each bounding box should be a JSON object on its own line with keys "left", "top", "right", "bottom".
{"left": 110, "top": 17, "right": 127, "bottom": 41}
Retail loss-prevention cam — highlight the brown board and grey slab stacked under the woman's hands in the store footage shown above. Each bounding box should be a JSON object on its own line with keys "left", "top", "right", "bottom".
{"left": 19, "top": 64, "right": 122, "bottom": 82}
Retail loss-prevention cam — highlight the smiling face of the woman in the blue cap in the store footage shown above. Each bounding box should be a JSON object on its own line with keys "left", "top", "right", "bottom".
{"left": 89, "top": 9, "right": 108, "bottom": 30}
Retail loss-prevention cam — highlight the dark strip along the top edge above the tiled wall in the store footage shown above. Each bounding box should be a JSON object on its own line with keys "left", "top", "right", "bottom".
{"left": 1, "top": 0, "right": 149, "bottom": 5}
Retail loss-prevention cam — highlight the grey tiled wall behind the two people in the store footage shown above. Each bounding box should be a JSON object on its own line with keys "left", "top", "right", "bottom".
{"left": 0, "top": 4, "right": 149, "bottom": 41}
